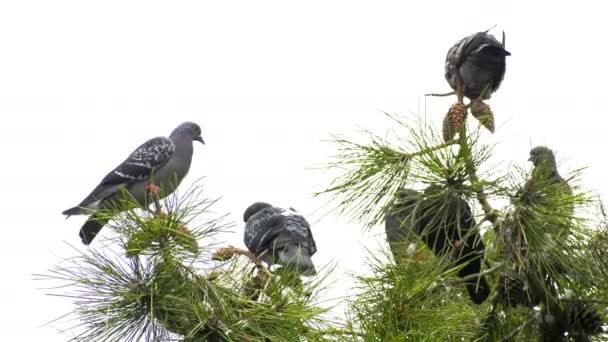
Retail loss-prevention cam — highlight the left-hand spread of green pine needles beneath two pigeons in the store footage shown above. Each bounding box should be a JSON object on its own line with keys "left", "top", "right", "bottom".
{"left": 39, "top": 186, "right": 341, "bottom": 341}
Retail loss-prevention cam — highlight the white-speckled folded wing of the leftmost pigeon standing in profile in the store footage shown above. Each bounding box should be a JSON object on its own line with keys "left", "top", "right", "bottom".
{"left": 64, "top": 137, "right": 175, "bottom": 211}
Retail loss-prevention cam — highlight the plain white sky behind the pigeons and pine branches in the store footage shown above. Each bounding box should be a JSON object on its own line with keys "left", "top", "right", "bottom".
{"left": 0, "top": 0, "right": 608, "bottom": 341}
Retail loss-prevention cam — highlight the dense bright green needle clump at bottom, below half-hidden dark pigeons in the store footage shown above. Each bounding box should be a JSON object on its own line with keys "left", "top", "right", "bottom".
{"left": 349, "top": 248, "right": 487, "bottom": 341}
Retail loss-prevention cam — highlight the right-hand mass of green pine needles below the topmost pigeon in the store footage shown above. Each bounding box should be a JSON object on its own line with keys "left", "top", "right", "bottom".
{"left": 317, "top": 113, "right": 608, "bottom": 341}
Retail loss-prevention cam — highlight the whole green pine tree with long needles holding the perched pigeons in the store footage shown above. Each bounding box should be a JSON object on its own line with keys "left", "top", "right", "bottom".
{"left": 42, "top": 106, "right": 608, "bottom": 341}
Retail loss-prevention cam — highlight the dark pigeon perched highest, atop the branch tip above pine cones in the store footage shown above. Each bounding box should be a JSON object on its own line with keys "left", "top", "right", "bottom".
{"left": 445, "top": 31, "right": 511, "bottom": 100}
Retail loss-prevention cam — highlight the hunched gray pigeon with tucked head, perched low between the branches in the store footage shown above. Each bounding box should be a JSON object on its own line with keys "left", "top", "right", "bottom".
{"left": 243, "top": 202, "right": 317, "bottom": 275}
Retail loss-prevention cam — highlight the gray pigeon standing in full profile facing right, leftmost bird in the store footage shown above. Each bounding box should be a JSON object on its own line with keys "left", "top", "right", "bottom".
{"left": 63, "top": 122, "right": 205, "bottom": 245}
